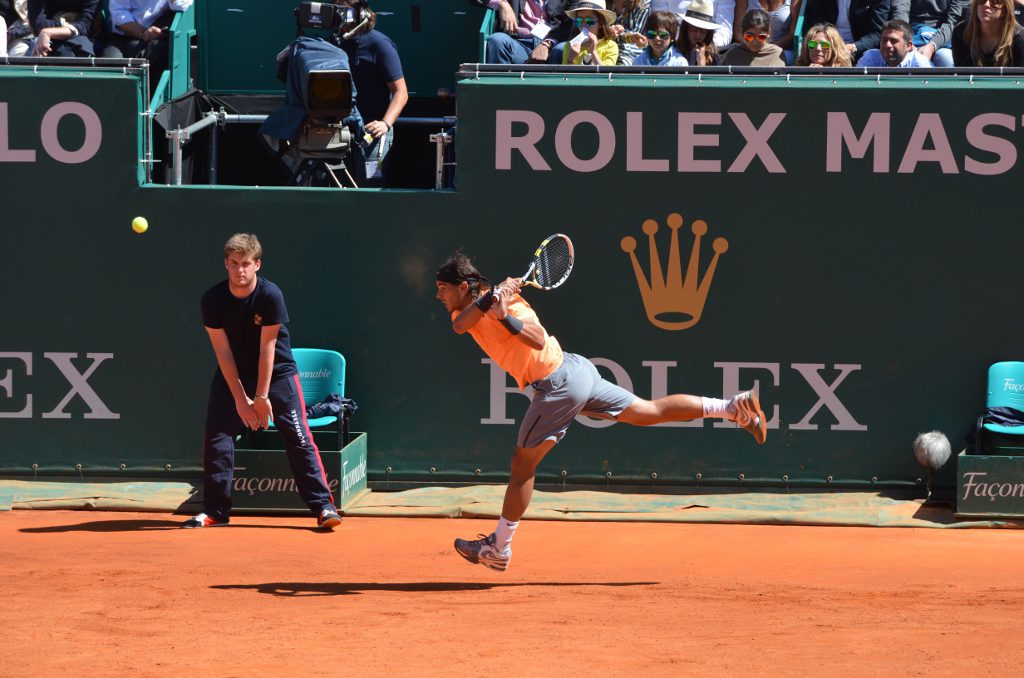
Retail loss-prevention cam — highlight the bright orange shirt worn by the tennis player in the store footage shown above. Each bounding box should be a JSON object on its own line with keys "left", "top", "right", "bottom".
{"left": 452, "top": 294, "right": 562, "bottom": 390}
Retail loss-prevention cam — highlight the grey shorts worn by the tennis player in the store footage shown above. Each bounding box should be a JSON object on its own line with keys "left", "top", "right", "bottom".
{"left": 516, "top": 353, "right": 637, "bottom": 448}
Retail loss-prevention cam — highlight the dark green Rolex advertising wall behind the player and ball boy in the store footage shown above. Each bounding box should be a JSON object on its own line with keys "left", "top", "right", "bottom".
{"left": 0, "top": 69, "right": 1024, "bottom": 488}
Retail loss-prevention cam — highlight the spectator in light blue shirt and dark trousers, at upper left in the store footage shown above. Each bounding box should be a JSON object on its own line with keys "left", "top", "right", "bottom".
{"left": 99, "top": 0, "right": 193, "bottom": 87}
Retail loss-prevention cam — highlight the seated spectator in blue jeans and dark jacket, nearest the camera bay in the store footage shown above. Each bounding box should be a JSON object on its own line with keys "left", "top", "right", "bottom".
{"left": 484, "top": 0, "right": 571, "bottom": 63}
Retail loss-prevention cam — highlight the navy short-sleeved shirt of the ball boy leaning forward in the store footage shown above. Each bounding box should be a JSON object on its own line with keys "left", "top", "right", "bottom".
{"left": 200, "top": 277, "right": 298, "bottom": 379}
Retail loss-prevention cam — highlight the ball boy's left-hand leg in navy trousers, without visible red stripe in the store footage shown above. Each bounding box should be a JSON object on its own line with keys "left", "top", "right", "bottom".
{"left": 182, "top": 372, "right": 244, "bottom": 527}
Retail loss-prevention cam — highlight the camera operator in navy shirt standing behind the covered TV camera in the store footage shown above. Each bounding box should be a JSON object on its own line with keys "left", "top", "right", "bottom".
{"left": 337, "top": 0, "right": 409, "bottom": 185}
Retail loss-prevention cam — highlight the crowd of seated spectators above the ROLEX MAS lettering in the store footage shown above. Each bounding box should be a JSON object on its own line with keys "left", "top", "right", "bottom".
{"left": 477, "top": 0, "right": 1024, "bottom": 68}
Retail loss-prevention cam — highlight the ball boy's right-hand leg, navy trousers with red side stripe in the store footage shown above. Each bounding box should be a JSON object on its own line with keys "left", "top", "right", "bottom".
{"left": 267, "top": 375, "right": 341, "bottom": 528}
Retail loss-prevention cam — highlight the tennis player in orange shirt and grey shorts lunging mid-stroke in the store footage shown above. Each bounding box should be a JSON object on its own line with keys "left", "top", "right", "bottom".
{"left": 436, "top": 252, "right": 767, "bottom": 571}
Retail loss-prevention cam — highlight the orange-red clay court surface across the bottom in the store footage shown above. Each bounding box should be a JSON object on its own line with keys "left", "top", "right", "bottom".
{"left": 0, "top": 511, "right": 1024, "bottom": 678}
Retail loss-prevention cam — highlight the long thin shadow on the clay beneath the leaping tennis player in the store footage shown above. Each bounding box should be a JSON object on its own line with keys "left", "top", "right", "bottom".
{"left": 210, "top": 582, "right": 660, "bottom": 597}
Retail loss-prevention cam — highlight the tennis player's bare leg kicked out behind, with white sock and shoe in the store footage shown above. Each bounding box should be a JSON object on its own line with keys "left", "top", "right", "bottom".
{"left": 610, "top": 387, "right": 768, "bottom": 444}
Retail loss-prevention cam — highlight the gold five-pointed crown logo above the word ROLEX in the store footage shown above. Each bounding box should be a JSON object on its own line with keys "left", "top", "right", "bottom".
{"left": 622, "top": 214, "right": 729, "bottom": 330}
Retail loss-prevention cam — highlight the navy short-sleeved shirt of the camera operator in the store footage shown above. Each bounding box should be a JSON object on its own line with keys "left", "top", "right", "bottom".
{"left": 341, "top": 30, "right": 402, "bottom": 122}
